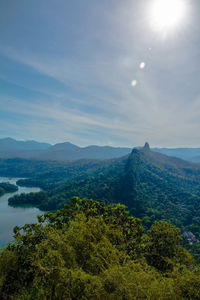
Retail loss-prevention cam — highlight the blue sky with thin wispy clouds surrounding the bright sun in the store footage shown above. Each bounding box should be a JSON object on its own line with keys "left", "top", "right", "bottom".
{"left": 0, "top": 0, "right": 200, "bottom": 147}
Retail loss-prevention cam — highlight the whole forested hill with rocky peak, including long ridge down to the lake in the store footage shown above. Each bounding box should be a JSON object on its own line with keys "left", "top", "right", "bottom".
{"left": 10, "top": 144, "right": 200, "bottom": 233}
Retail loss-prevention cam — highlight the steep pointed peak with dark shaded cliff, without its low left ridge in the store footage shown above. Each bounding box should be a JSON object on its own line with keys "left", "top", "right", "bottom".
{"left": 117, "top": 145, "right": 200, "bottom": 226}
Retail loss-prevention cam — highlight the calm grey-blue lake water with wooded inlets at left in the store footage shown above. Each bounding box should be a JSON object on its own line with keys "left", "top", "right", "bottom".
{"left": 0, "top": 177, "right": 42, "bottom": 247}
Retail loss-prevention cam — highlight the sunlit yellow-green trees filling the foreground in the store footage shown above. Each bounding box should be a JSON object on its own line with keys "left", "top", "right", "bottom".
{"left": 0, "top": 197, "right": 200, "bottom": 300}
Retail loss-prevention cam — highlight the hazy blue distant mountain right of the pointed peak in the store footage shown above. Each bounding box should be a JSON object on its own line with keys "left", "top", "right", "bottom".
{"left": 152, "top": 148, "right": 200, "bottom": 162}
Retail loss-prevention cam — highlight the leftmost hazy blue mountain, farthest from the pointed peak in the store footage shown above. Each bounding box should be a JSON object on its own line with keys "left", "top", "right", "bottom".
{"left": 0, "top": 138, "right": 51, "bottom": 158}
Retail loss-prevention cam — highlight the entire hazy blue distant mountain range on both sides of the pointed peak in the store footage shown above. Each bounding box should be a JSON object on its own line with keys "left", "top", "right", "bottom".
{"left": 0, "top": 138, "right": 200, "bottom": 162}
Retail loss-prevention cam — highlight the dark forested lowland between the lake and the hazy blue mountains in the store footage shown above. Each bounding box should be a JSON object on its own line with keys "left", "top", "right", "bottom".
{"left": 0, "top": 158, "right": 114, "bottom": 190}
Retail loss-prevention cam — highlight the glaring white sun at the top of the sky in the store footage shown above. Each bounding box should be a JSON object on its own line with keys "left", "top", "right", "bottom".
{"left": 150, "top": 0, "right": 186, "bottom": 33}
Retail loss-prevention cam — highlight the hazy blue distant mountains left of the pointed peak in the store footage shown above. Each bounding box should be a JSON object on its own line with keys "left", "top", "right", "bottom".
{"left": 0, "top": 138, "right": 131, "bottom": 162}
